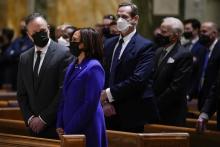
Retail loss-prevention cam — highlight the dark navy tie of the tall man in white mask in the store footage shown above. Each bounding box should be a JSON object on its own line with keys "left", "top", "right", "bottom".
{"left": 109, "top": 38, "right": 124, "bottom": 86}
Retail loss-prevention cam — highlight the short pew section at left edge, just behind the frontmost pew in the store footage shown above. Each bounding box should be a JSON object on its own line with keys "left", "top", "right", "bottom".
{"left": 0, "top": 107, "right": 23, "bottom": 120}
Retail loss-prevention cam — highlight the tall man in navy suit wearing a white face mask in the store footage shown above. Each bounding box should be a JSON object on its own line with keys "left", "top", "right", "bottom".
{"left": 102, "top": 3, "right": 158, "bottom": 132}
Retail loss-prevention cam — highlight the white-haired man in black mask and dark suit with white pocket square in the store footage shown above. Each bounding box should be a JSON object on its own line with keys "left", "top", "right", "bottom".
{"left": 153, "top": 17, "right": 193, "bottom": 125}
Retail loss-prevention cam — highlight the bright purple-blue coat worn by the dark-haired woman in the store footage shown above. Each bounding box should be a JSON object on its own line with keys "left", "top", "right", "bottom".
{"left": 57, "top": 59, "right": 107, "bottom": 147}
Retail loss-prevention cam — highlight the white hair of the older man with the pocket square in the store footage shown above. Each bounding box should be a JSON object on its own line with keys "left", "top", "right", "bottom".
{"left": 163, "top": 17, "right": 184, "bottom": 36}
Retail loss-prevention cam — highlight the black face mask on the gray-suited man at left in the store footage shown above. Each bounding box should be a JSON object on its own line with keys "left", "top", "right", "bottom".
{"left": 32, "top": 31, "right": 49, "bottom": 47}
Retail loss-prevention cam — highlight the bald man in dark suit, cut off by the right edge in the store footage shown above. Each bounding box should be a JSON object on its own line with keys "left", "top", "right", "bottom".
{"left": 197, "top": 22, "right": 220, "bottom": 132}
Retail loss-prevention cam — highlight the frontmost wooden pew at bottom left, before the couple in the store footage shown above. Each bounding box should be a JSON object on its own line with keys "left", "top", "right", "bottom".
{"left": 0, "top": 133, "right": 85, "bottom": 147}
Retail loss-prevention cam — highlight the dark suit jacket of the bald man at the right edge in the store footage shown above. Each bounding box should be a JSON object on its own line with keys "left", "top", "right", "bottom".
{"left": 198, "top": 40, "right": 220, "bottom": 110}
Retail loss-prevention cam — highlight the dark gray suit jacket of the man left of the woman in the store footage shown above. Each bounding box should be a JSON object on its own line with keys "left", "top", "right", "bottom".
{"left": 17, "top": 40, "right": 70, "bottom": 126}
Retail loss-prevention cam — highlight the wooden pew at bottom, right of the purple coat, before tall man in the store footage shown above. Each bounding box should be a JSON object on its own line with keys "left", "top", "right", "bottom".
{"left": 107, "top": 130, "right": 189, "bottom": 147}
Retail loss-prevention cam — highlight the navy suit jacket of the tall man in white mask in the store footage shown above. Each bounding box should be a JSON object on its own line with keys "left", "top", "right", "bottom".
{"left": 104, "top": 33, "right": 158, "bottom": 131}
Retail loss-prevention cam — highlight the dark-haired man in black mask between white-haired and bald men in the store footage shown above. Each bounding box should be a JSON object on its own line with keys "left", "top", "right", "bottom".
{"left": 183, "top": 18, "right": 206, "bottom": 100}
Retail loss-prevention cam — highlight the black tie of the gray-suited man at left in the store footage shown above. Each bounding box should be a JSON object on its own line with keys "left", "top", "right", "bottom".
{"left": 34, "top": 51, "right": 41, "bottom": 91}
